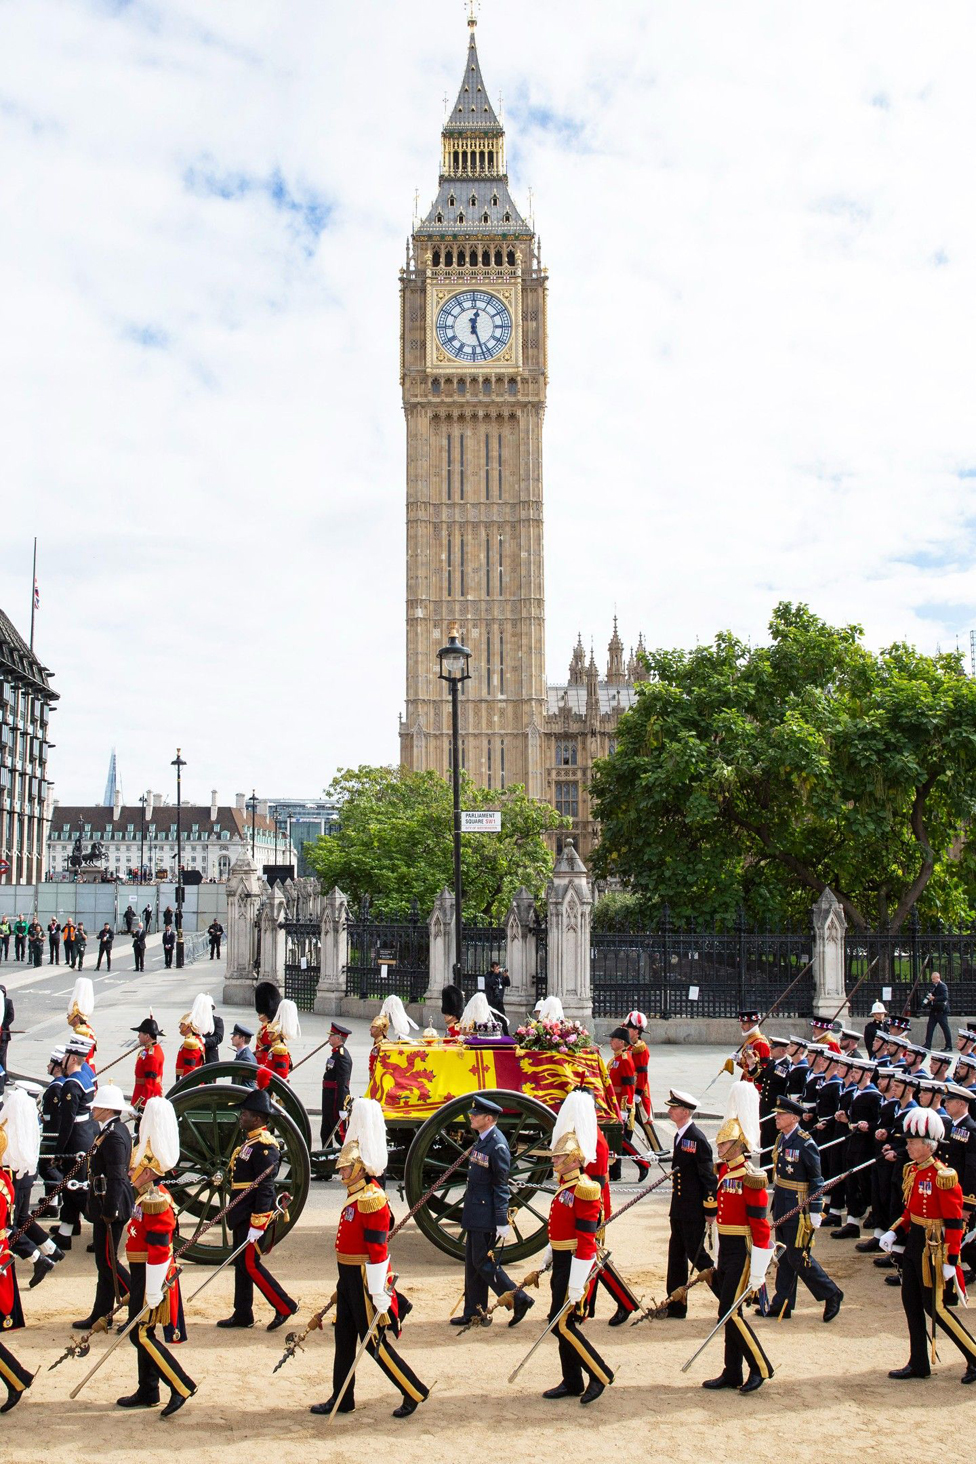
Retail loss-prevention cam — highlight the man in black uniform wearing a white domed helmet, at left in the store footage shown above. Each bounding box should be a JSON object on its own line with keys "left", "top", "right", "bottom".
{"left": 72, "top": 1083, "right": 132, "bottom": 1332}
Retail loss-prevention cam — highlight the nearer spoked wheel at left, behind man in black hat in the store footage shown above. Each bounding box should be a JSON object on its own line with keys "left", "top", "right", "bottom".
{"left": 165, "top": 1075, "right": 310, "bottom": 1265}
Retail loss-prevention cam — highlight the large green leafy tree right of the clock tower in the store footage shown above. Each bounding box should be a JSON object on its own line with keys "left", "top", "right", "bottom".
{"left": 593, "top": 603, "right": 976, "bottom": 930}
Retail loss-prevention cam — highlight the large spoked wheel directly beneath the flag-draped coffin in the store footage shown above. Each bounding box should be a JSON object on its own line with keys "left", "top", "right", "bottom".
{"left": 404, "top": 1089, "right": 556, "bottom": 1262}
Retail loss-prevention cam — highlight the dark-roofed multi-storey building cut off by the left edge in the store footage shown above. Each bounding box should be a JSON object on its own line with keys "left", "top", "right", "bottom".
{"left": 0, "top": 610, "right": 59, "bottom": 884}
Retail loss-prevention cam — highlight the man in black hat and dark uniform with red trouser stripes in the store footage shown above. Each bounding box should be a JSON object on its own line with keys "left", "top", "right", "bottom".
{"left": 217, "top": 1067, "right": 299, "bottom": 1332}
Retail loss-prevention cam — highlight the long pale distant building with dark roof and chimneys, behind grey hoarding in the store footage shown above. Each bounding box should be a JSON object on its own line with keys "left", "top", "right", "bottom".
{"left": 47, "top": 791, "right": 294, "bottom": 883}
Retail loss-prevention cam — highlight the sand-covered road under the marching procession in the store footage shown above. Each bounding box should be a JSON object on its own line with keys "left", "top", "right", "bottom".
{"left": 9, "top": 1184, "right": 976, "bottom": 1464}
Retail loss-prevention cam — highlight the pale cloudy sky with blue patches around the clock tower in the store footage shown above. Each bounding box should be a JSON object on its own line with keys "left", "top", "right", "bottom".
{"left": 0, "top": 0, "right": 976, "bottom": 804}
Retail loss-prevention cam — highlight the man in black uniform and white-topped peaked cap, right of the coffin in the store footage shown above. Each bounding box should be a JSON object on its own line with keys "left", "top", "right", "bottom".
{"left": 667, "top": 1088, "right": 718, "bottom": 1318}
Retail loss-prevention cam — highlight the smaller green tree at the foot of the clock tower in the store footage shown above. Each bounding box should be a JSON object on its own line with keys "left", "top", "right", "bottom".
{"left": 306, "top": 767, "right": 565, "bottom": 918}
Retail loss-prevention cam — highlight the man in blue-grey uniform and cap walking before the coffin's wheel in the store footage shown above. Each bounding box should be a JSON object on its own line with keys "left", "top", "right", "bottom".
{"left": 451, "top": 1097, "right": 533, "bottom": 1326}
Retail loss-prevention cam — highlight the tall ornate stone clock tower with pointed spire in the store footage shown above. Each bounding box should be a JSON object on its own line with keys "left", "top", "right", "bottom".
{"left": 399, "top": 18, "right": 546, "bottom": 798}
